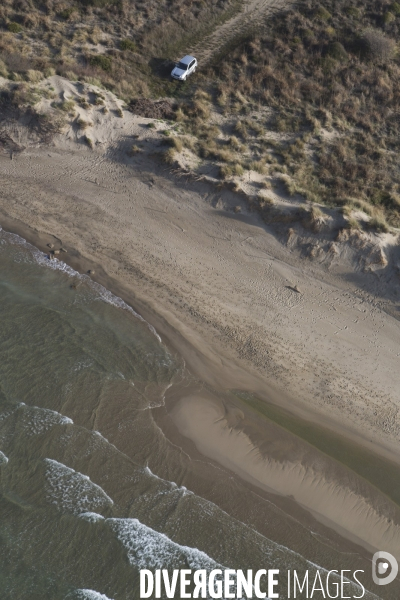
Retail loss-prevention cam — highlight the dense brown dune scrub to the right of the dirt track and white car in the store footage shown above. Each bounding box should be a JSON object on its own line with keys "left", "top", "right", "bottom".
{"left": 202, "top": 0, "right": 400, "bottom": 229}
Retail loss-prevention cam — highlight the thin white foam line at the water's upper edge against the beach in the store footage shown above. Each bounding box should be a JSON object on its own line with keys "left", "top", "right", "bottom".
{"left": 0, "top": 227, "right": 162, "bottom": 343}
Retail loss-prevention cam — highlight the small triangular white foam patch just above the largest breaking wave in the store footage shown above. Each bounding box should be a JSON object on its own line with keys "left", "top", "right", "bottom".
{"left": 44, "top": 458, "right": 113, "bottom": 515}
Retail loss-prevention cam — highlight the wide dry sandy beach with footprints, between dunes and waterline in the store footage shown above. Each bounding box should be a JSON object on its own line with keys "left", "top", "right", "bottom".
{"left": 0, "top": 124, "right": 400, "bottom": 456}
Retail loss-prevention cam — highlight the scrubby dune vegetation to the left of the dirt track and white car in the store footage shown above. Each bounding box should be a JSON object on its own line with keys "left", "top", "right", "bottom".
{"left": 0, "top": 0, "right": 241, "bottom": 100}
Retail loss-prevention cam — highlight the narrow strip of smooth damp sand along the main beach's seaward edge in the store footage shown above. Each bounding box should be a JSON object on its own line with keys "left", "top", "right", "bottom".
{"left": 0, "top": 205, "right": 400, "bottom": 465}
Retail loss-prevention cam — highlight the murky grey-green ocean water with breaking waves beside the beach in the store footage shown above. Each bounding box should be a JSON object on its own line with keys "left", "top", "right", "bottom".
{"left": 0, "top": 230, "right": 390, "bottom": 600}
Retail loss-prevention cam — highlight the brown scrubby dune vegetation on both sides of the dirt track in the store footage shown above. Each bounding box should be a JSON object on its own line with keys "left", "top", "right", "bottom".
{"left": 0, "top": 0, "right": 400, "bottom": 231}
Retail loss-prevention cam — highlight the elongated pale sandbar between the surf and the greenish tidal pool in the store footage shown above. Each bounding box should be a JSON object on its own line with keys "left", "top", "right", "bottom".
{"left": 171, "top": 396, "right": 400, "bottom": 559}
